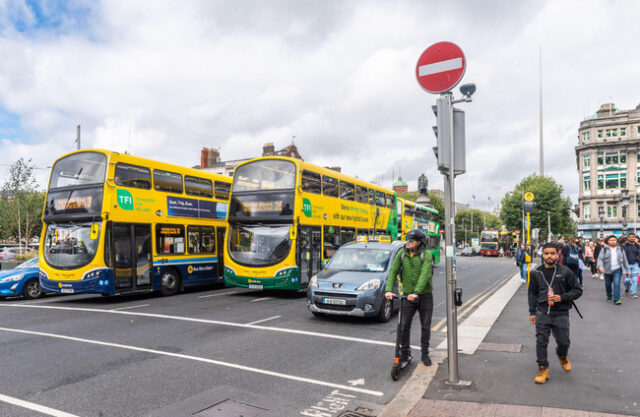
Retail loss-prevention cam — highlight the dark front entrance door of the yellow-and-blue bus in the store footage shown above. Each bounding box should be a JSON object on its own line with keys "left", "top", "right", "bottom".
{"left": 111, "top": 223, "right": 153, "bottom": 292}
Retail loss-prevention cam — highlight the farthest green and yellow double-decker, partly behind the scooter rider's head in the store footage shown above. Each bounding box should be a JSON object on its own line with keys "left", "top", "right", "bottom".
{"left": 397, "top": 198, "right": 440, "bottom": 264}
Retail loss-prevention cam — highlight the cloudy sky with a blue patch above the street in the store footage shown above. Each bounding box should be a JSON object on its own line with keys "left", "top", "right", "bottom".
{"left": 0, "top": 0, "right": 640, "bottom": 209}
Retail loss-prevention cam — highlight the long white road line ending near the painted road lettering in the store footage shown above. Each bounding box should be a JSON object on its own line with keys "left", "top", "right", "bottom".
{"left": 0, "top": 327, "right": 384, "bottom": 397}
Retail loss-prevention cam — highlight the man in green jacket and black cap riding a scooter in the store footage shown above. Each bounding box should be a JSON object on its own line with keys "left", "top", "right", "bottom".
{"left": 385, "top": 229, "right": 433, "bottom": 368}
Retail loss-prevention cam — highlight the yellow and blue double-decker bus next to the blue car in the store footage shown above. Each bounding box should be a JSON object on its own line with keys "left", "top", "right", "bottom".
{"left": 40, "top": 149, "right": 231, "bottom": 295}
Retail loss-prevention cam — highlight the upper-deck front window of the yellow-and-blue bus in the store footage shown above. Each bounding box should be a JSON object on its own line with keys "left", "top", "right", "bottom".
{"left": 49, "top": 152, "right": 107, "bottom": 189}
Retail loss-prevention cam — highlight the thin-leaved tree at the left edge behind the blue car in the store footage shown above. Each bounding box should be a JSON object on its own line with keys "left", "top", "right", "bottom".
{"left": 0, "top": 158, "right": 44, "bottom": 250}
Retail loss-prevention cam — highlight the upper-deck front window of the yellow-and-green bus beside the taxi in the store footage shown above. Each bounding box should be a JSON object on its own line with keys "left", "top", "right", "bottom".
{"left": 233, "top": 159, "right": 296, "bottom": 192}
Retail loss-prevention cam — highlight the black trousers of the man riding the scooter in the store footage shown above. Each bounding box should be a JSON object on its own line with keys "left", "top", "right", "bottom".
{"left": 400, "top": 293, "right": 433, "bottom": 358}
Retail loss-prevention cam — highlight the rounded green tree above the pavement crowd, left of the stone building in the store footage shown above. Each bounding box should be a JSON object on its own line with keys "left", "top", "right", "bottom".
{"left": 500, "top": 174, "right": 575, "bottom": 240}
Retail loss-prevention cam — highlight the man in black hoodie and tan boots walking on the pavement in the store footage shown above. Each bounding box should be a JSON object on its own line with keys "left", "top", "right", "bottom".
{"left": 529, "top": 243, "right": 582, "bottom": 384}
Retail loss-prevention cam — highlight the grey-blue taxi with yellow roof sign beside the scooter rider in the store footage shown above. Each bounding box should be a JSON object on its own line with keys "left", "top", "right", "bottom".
{"left": 307, "top": 241, "right": 404, "bottom": 323}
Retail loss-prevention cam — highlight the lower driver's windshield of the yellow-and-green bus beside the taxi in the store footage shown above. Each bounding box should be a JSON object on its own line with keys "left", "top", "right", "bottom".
{"left": 229, "top": 224, "right": 291, "bottom": 266}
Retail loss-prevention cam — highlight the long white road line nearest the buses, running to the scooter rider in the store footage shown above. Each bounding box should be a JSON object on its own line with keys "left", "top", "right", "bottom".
{"left": 0, "top": 303, "right": 420, "bottom": 349}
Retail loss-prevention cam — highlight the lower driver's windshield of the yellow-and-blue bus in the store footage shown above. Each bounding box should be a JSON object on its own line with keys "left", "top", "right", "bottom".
{"left": 43, "top": 222, "right": 100, "bottom": 269}
